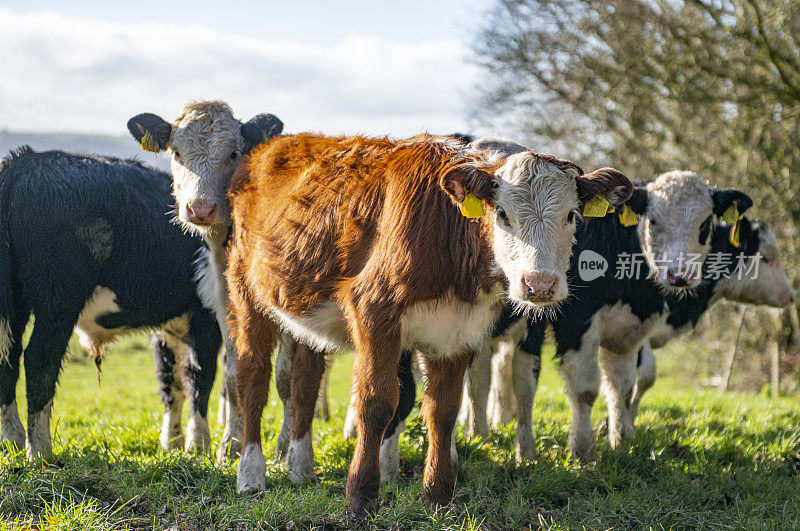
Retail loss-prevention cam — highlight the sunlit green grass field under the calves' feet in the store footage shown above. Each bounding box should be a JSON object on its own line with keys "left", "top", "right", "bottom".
{"left": 0, "top": 337, "right": 800, "bottom": 530}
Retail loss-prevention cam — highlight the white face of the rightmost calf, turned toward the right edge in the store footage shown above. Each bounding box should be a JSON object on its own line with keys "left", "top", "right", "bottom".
{"left": 718, "top": 224, "right": 795, "bottom": 308}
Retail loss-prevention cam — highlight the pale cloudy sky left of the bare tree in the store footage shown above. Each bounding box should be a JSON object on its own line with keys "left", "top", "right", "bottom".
{"left": 0, "top": 0, "right": 493, "bottom": 136}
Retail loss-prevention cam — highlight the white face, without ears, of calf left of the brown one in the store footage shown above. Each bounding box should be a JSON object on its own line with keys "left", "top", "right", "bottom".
{"left": 169, "top": 101, "right": 245, "bottom": 231}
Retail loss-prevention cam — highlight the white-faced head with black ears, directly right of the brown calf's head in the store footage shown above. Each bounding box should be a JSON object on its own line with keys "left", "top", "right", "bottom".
{"left": 628, "top": 171, "right": 753, "bottom": 290}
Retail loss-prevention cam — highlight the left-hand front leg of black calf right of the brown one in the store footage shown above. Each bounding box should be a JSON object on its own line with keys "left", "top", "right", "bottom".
{"left": 560, "top": 338, "right": 600, "bottom": 463}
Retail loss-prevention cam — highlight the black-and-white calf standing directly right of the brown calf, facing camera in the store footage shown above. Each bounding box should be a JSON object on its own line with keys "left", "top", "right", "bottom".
{"left": 460, "top": 166, "right": 752, "bottom": 460}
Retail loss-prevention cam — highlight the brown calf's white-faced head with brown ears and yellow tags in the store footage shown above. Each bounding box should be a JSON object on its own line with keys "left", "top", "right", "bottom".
{"left": 441, "top": 151, "right": 633, "bottom": 310}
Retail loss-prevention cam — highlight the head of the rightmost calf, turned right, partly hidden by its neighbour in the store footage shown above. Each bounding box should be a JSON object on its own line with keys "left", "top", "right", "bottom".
{"left": 711, "top": 218, "right": 795, "bottom": 308}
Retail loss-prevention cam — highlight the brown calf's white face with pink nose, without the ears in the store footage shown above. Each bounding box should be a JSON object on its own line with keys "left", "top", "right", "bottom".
{"left": 494, "top": 152, "right": 578, "bottom": 306}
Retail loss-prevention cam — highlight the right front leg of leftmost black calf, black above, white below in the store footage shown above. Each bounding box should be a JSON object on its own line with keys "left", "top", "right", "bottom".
{"left": 184, "top": 310, "right": 222, "bottom": 453}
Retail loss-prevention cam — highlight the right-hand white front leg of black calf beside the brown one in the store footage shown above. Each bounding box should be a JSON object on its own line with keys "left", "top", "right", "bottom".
{"left": 600, "top": 347, "right": 638, "bottom": 448}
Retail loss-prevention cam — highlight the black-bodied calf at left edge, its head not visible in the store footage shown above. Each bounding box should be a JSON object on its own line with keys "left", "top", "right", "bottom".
{"left": 0, "top": 147, "right": 221, "bottom": 458}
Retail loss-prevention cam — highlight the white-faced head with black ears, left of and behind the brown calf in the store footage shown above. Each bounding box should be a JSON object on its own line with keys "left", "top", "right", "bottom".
{"left": 128, "top": 100, "right": 283, "bottom": 239}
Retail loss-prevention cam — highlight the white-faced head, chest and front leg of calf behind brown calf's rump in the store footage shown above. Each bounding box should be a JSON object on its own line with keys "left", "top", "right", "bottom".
{"left": 128, "top": 100, "right": 283, "bottom": 462}
